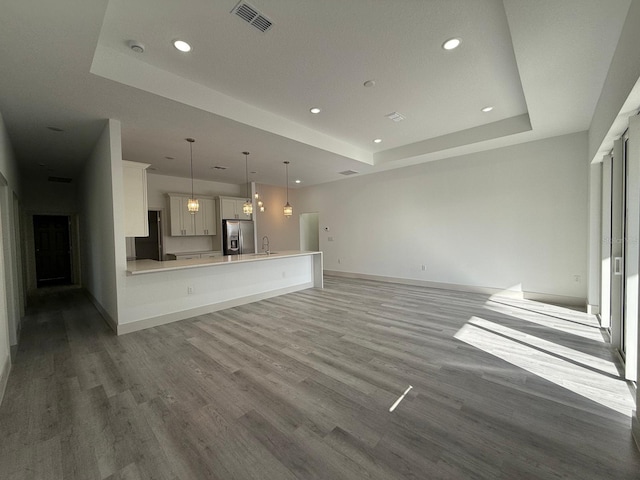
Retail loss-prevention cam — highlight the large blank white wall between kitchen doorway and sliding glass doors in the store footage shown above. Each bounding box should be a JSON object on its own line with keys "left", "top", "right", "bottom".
{"left": 296, "top": 132, "right": 588, "bottom": 301}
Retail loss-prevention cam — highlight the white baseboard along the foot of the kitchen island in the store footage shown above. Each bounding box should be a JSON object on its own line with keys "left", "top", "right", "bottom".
{"left": 114, "top": 282, "right": 314, "bottom": 335}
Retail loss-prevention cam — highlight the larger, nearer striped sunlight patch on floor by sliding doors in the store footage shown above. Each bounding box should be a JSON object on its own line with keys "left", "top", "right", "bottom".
{"left": 455, "top": 317, "right": 635, "bottom": 417}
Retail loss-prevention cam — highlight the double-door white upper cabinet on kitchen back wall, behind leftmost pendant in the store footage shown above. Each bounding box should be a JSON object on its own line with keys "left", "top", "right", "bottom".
{"left": 167, "top": 193, "right": 217, "bottom": 237}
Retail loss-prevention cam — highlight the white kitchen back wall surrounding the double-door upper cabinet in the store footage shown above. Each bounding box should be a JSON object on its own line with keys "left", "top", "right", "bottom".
{"left": 147, "top": 172, "right": 244, "bottom": 253}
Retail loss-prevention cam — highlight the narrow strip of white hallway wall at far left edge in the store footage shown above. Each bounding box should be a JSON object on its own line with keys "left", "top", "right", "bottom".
{"left": 0, "top": 114, "right": 24, "bottom": 402}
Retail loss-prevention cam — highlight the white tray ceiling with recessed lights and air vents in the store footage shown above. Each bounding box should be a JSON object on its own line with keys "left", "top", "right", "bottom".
{"left": 0, "top": 0, "right": 630, "bottom": 186}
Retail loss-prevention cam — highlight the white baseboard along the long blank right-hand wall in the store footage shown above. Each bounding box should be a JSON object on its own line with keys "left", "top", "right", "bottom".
{"left": 324, "top": 270, "right": 587, "bottom": 308}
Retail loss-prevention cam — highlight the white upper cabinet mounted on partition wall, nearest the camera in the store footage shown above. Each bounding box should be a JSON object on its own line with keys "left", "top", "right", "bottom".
{"left": 122, "top": 160, "right": 149, "bottom": 237}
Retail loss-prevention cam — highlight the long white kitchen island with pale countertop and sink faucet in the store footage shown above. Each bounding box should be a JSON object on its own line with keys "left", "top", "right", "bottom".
{"left": 115, "top": 251, "right": 323, "bottom": 335}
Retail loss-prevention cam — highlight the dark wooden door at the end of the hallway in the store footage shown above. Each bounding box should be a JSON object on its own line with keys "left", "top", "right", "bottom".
{"left": 33, "top": 215, "right": 71, "bottom": 288}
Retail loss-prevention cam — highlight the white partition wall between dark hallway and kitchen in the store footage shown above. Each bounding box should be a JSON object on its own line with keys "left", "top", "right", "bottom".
{"left": 79, "top": 120, "right": 126, "bottom": 328}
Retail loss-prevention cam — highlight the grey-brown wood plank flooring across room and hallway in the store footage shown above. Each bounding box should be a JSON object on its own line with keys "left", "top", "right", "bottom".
{"left": 0, "top": 277, "right": 640, "bottom": 480}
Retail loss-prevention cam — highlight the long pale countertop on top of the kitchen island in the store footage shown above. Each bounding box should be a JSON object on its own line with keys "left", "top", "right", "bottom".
{"left": 127, "top": 250, "right": 321, "bottom": 275}
